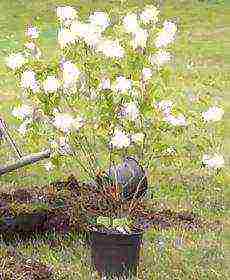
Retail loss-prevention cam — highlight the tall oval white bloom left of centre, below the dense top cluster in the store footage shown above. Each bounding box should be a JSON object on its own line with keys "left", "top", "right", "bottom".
{"left": 62, "top": 61, "right": 80, "bottom": 88}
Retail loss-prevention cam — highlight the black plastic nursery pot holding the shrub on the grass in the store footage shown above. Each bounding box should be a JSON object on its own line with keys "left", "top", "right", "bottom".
{"left": 90, "top": 231, "right": 142, "bottom": 279}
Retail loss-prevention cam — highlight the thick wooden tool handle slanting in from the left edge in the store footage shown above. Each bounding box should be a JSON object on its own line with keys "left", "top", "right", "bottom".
{"left": 0, "top": 150, "right": 51, "bottom": 176}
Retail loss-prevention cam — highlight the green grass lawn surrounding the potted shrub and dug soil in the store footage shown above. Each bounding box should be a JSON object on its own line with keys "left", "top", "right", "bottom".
{"left": 0, "top": 0, "right": 230, "bottom": 280}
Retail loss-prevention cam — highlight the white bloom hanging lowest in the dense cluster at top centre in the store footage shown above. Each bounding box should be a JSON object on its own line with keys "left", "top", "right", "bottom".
{"left": 97, "top": 39, "right": 125, "bottom": 58}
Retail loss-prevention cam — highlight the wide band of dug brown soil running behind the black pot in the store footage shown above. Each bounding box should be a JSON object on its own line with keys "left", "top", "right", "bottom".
{"left": 0, "top": 176, "right": 220, "bottom": 238}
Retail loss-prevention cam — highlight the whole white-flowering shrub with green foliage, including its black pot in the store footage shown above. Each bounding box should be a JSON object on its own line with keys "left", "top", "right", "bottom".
{"left": 4, "top": 1, "right": 224, "bottom": 278}
